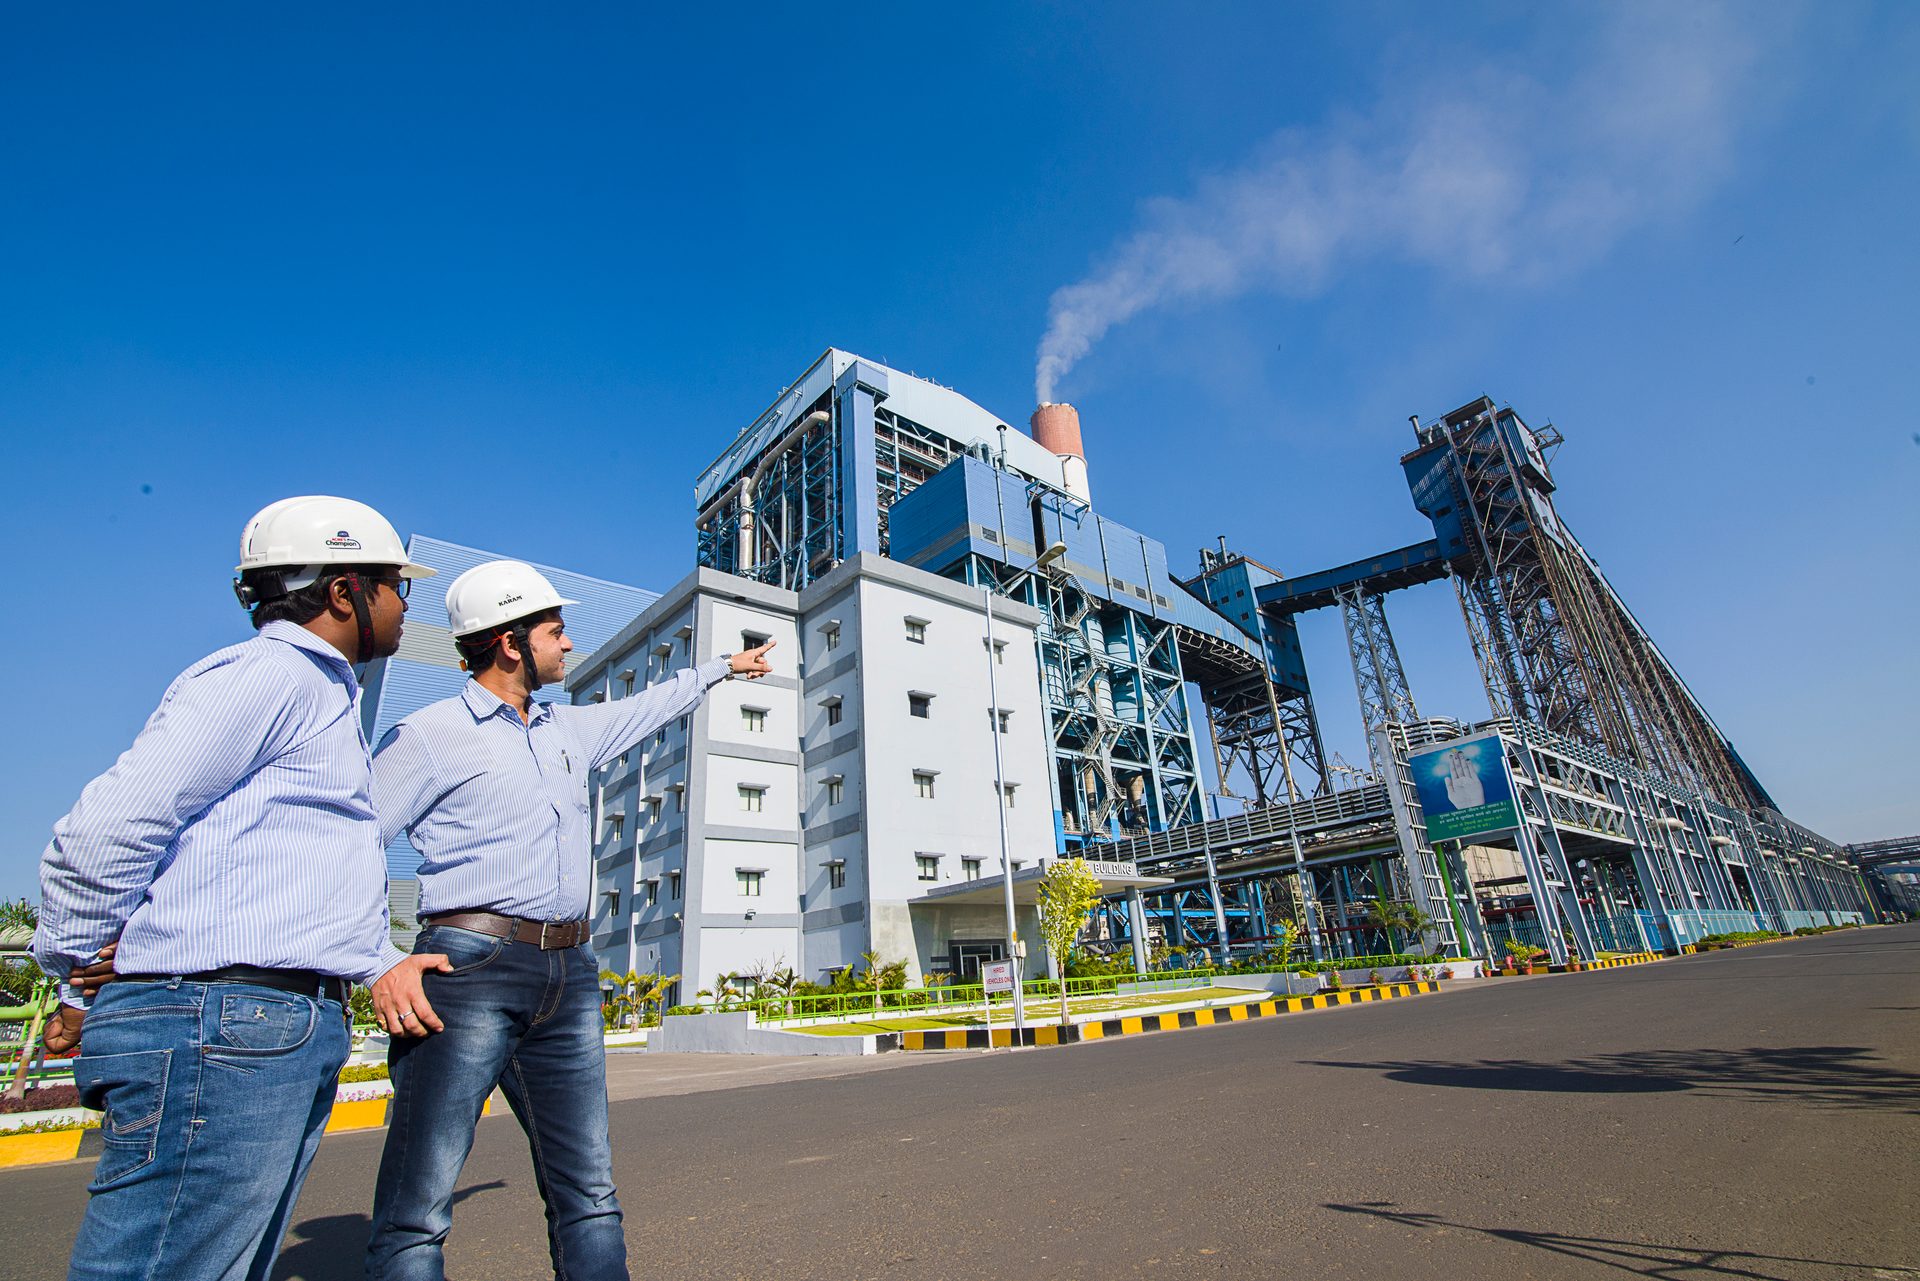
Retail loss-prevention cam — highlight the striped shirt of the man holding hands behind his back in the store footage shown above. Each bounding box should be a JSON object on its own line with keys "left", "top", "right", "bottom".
{"left": 33, "top": 622, "right": 401, "bottom": 1004}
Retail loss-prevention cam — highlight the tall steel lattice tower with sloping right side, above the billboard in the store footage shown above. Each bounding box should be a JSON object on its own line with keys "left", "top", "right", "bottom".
{"left": 1402, "top": 398, "right": 1770, "bottom": 807}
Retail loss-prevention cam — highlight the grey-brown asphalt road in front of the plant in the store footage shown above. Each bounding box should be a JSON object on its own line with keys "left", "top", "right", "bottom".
{"left": 0, "top": 926, "right": 1920, "bottom": 1281}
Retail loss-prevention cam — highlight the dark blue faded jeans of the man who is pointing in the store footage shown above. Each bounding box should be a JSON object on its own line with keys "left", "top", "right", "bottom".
{"left": 367, "top": 926, "right": 628, "bottom": 1281}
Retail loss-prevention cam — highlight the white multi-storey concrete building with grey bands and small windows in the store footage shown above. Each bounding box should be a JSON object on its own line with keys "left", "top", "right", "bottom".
{"left": 568, "top": 553, "right": 1058, "bottom": 1001}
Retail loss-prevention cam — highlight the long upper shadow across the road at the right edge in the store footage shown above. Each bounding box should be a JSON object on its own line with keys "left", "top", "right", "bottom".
{"left": 1311, "top": 1045, "right": 1920, "bottom": 1114}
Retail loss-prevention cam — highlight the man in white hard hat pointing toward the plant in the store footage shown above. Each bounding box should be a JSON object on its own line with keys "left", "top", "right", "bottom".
{"left": 367, "top": 561, "right": 774, "bottom": 1281}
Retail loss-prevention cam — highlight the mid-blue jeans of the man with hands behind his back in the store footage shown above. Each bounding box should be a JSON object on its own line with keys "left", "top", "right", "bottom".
{"left": 67, "top": 979, "right": 348, "bottom": 1281}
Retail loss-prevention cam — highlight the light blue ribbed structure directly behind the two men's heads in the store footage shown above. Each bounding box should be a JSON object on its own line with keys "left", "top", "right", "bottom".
{"left": 361, "top": 534, "right": 660, "bottom": 880}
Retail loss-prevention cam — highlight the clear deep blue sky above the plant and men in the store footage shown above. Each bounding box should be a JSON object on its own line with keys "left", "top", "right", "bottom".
{"left": 0, "top": 4, "right": 1920, "bottom": 895}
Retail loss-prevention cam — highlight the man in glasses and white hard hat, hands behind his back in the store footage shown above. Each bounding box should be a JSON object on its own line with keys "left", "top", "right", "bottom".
{"left": 35, "top": 497, "right": 453, "bottom": 1281}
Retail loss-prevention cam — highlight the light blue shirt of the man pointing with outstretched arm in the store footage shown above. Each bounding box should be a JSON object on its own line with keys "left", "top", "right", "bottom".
{"left": 372, "top": 659, "right": 728, "bottom": 920}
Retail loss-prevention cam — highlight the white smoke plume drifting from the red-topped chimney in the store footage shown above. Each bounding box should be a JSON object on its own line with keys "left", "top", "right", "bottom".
{"left": 1035, "top": 2, "right": 1793, "bottom": 403}
